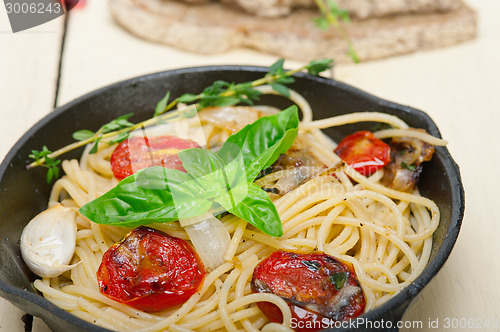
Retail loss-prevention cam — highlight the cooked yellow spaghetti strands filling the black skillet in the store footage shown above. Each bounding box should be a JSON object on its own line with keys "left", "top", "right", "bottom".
{"left": 34, "top": 87, "right": 446, "bottom": 332}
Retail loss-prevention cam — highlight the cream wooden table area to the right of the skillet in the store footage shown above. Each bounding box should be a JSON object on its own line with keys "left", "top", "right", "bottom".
{"left": 336, "top": 0, "right": 500, "bottom": 331}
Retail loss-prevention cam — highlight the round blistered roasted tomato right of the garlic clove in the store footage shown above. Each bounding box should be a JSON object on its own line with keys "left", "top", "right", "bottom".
{"left": 97, "top": 226, "right": 206, "bottom": 312}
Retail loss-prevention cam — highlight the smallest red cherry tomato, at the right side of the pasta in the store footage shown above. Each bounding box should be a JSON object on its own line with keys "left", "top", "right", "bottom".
{"left": 335, "top": 131, "right": 391, "bottom": 176}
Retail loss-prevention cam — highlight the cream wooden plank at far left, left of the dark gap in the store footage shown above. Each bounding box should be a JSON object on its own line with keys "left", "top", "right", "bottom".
{"left": 0, "top": 4, "right": 64, "bottom": 332}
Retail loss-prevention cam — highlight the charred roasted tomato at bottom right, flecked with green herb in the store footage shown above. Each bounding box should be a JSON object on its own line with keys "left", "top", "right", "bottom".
{"left": 251, "top": 251, "right": 366, "bottom": 331}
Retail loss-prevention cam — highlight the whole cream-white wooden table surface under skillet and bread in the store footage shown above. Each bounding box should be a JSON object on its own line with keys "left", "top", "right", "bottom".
{"left": 0, "top": 0, "right": 500, "bottom": 332}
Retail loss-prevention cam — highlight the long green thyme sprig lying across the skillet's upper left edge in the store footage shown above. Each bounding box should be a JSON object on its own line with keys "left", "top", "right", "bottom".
{"left": 27, "top": 59, "right": 333, "bottom": 182}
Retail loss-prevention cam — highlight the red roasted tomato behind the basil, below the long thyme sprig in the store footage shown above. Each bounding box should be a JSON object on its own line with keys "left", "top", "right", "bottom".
{"left": 111, "top": 136, "right": 200, "bottom": 180}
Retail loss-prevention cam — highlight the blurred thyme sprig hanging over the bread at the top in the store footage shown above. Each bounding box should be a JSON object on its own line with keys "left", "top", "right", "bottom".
{"left": 314, "top": 0, "right": 359, "bottom": 63}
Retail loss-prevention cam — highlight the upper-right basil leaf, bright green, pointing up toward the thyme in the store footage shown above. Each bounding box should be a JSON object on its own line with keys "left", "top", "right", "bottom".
{"left": 217, "top": 106, "right": 299, "bottom": 181}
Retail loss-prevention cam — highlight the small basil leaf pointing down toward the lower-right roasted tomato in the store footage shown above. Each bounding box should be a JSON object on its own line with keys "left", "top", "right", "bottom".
{"left": 221, "top": 183, "right": 283, "bottom": 237}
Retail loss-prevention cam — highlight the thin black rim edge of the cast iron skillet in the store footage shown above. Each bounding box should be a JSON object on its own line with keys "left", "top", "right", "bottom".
{"left": 0, "top": 65, "right": 465, "bottom": 332}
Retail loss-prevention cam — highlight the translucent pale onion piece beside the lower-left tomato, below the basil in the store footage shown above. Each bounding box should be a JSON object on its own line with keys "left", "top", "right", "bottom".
{"left": 180, "top": 213, "right": 231, "bottom": 270}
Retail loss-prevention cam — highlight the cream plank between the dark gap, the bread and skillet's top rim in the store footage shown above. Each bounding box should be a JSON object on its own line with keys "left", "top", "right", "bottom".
{"left": 59, "top": 0, "right": 299, "bottom": 104}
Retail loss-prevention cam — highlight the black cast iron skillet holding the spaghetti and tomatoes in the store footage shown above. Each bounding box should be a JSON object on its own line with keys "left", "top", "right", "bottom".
{"left": 0, "top": 66, "right": 465, "bottom": 331}
